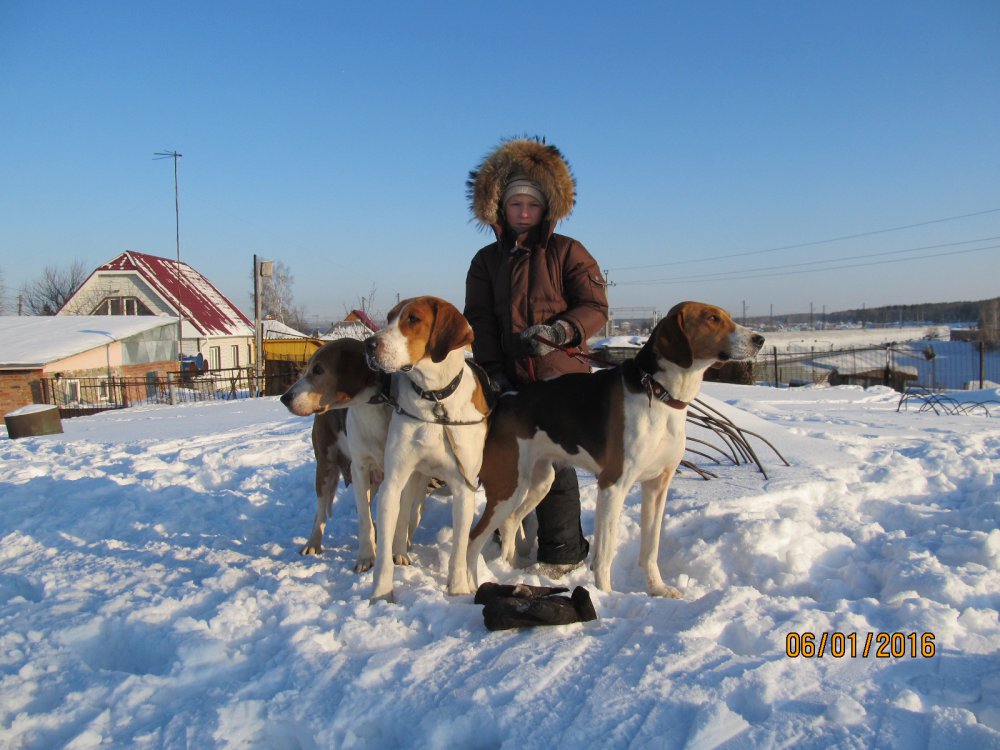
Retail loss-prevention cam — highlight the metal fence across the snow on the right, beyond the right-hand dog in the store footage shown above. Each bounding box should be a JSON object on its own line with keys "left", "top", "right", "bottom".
{"left": 753, "top": 341, "right": 1000, "bottom": 392}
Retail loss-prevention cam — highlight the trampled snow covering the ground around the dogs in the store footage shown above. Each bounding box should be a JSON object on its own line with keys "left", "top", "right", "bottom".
{"left": 0, "top": 384, "right": 1000, "bottom": 750}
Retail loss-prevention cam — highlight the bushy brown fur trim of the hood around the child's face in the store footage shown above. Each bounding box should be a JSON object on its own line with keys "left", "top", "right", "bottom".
{"left": 466, "top": 137, "right": 576, "bottom": 231}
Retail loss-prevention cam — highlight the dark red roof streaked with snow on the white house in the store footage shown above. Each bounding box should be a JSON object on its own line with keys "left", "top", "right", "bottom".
{"left": 95, "top": 251, "right": 253, "bottom": 336}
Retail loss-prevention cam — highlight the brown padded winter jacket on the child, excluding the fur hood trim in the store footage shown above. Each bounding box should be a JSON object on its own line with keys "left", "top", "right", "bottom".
{"left": 465, "top": 221, "right": 608, "bottom": 384}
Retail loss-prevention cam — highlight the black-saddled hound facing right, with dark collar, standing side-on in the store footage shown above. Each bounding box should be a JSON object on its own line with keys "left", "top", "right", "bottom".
{"left": 468, "top": 302, "right": 764, "bottom": 597}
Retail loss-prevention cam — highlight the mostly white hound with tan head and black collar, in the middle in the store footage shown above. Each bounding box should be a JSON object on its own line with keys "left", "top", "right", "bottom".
{"left": 365, "top": 297, "right": 489, "bottom": 601}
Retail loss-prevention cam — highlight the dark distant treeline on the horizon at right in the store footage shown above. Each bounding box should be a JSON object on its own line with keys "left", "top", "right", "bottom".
{"left": 750, "top": 297, "right": 1000, "bottom": 328}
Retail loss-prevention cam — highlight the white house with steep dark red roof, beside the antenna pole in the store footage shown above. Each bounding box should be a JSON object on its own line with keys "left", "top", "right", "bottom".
{"left": 56, "top": 251, "right": 254, "bottom": 370}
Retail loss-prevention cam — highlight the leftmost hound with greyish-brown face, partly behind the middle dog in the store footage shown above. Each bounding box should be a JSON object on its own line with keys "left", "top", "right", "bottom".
{"left": 281, "top": 339, "right": 422, "bottom": 573}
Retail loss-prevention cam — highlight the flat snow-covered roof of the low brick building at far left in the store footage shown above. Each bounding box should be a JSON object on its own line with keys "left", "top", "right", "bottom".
{"left": 0, "top": 315, "right": 177, "bottom": 369}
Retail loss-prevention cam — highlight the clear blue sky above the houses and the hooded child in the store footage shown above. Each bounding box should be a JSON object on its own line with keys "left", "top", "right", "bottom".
{"left": 0, "top": 0, "right": 1000, "bottom": 321}
